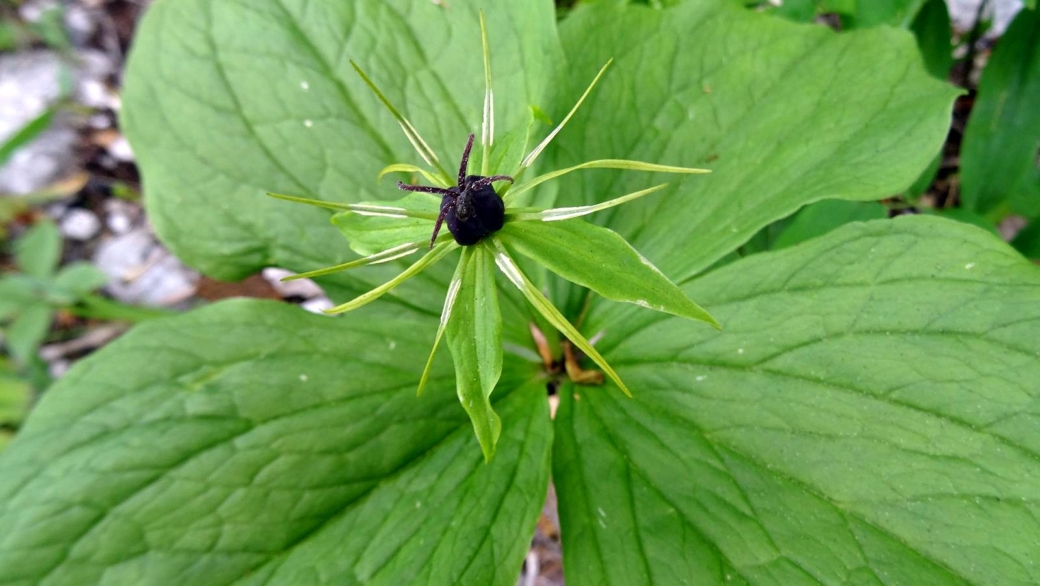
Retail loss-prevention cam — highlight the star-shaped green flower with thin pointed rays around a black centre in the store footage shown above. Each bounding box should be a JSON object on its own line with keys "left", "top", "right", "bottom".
{"left": 269, "top": 15, "right": 719, "bottom": 460}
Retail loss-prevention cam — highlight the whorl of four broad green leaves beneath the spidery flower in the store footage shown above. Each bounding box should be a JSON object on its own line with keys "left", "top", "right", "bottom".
{"left": 0, "top": 0, "right": 1040, "bottom": 584}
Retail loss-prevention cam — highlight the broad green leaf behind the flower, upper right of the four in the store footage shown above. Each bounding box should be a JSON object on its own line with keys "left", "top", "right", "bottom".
{"left": 549, "top": 1, "right": 957, "bottom": 289}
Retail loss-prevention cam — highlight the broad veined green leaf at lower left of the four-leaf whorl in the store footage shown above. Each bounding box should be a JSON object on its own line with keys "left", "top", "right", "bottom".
{"left": 0, "top": 301, "right": 551, "bottom": 584}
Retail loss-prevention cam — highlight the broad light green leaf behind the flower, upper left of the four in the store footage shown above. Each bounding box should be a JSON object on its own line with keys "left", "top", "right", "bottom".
{"left": 123, "top": 0, "right": 561, "bottom": 312}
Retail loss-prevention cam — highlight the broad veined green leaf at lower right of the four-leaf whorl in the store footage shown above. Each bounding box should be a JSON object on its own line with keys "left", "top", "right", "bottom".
{"left": 553, "top": 216, "right": 1040, "bottom": 585}
